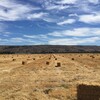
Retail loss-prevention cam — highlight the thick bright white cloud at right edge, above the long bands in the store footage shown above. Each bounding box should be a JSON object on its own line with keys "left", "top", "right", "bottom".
{"left": 79, "top": 14, "right": 100, "bottom": 24}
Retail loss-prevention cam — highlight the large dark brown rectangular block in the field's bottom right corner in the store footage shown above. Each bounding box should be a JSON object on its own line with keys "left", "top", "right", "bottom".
{"left": 77, "top": 84, "right": 100, "bottom": 100}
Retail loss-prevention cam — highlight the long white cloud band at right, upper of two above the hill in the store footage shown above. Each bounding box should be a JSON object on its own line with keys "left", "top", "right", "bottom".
{"left": 48, "top": 28, "right": 100, "bottom": 37}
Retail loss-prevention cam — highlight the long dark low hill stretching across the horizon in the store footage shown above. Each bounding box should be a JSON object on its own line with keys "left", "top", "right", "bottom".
{"left": 0, "top": 45, "right": 100, "bottom": 54}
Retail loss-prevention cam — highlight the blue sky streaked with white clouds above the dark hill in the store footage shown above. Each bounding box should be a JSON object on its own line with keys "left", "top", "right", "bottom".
{"left": 0, "top": 0, "right": 100, "bottom": 46}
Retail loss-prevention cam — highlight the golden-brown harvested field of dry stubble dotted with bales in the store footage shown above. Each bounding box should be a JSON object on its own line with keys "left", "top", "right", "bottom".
{"left": 0, "top": 53, "right": 100, "bottom": 100}
